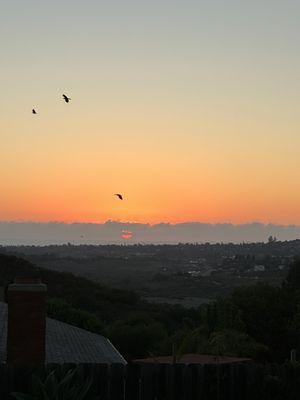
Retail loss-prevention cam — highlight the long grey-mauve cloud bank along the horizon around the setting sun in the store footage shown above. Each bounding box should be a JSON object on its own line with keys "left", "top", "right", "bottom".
{"left": 0, "top": 221, "right": 300, "bottom": 245}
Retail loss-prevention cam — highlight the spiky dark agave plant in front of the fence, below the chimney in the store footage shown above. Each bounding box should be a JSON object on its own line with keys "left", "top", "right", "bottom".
{"left": 11, "top": 369, "right": 98, "bottom": 400}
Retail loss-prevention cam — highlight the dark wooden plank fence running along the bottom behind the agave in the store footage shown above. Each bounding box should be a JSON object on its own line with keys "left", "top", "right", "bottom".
{"left": 0, "top": 363, "right": 300, "bottom": 400}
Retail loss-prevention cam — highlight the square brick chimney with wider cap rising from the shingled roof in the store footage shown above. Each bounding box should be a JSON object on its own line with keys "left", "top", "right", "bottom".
{"left": 7, "top": 278, "right": 47, "bottom": 365}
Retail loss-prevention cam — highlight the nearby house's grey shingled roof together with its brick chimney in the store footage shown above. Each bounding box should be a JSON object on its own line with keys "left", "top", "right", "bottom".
{"left": 0, "top": 279, "right": 126, "bottom": 365}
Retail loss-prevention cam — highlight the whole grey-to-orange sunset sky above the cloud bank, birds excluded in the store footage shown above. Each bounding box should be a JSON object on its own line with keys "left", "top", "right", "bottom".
{"left": 0, "top": 0, "right": 300, "bottom": 224}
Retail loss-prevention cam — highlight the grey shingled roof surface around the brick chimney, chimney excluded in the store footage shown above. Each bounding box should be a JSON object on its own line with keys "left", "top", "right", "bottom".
{"left": 0, "top": 302, "right": 126, "bottom": 364}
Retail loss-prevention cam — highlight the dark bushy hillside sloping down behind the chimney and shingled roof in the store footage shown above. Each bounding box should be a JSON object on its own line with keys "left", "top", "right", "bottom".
{"left": 0, "top": 254, "right": 199, "bottom": 359}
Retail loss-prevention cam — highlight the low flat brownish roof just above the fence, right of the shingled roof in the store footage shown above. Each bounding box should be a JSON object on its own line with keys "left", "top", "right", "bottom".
{"left": 134, "top": 354, "right": 252, "bottom": 365}
